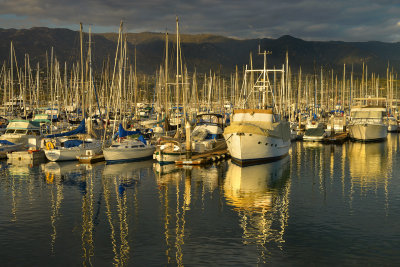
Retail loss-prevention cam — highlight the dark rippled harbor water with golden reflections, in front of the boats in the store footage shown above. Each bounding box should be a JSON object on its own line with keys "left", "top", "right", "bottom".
{"left": 0, "top": 134, "right": 400, "bottom": 266}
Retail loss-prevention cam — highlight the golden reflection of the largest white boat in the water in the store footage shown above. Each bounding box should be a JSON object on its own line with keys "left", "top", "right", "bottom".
{"left": 224, "top": 157, "right": 290, "bottom": 263}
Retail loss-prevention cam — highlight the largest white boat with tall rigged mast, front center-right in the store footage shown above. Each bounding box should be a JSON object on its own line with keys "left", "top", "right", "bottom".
{"left": 224, "top": 48, "right": 290, "bottom": 165}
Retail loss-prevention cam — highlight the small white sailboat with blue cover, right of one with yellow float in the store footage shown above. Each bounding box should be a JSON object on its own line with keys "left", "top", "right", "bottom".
{"left": 103, "top": 124, "right": 156, "bottom": 163}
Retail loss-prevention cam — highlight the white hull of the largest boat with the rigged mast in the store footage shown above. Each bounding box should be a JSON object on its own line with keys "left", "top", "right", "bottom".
{"left": 224, "top": 133, "right": 290, "bottom": 165}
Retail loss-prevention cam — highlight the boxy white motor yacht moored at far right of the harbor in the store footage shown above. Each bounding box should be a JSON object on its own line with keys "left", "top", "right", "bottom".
{"left": 348, "top": 106, "right": 388, "bottom": 141}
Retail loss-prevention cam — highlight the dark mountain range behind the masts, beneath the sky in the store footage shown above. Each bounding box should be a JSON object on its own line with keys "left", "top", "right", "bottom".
{"left": 0, "top": 27, "right": 400, "bottom": 77}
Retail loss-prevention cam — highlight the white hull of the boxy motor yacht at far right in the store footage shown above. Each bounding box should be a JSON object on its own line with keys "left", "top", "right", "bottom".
{"left": 349, "top": 124, "right": 388, "bottom": 141}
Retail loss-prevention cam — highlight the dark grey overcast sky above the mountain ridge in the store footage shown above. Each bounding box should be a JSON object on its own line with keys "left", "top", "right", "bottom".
{"left": 0, "top": 0, "right": 400, "bottom": 42}
